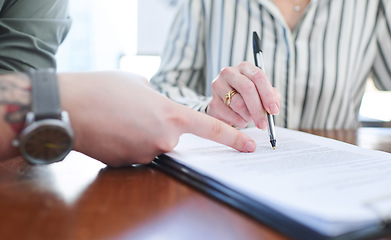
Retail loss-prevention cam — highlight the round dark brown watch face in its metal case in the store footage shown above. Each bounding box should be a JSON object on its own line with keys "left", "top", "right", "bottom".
{"left": 20, "top": 120, "right": 73, "bottom": 164}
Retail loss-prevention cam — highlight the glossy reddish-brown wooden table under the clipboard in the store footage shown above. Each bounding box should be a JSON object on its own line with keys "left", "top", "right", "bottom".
{"left": 0, "top": 128, "right": 391, "bottom": 240}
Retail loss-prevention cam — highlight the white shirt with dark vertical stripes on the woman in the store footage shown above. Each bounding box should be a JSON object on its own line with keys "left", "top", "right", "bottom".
{"left": 151, "top": 0, "right": 391, "bottom": 129}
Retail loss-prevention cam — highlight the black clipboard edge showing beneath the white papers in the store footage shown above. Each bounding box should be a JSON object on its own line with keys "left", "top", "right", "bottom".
{"left": 151, "top": 154, "right": 391, "bottom": 240}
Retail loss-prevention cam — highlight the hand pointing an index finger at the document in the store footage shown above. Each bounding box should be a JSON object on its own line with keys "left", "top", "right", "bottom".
{"left": 59, "top": 72, "right": 256, "bottom": 166}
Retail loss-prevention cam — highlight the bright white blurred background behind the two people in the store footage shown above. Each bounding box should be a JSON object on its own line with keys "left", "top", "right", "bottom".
{"left": 57, "top": 0, "right": 391, "bottom": 126}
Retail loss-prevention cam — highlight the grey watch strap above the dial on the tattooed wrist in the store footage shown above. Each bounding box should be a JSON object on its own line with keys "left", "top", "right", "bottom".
{"left": 28, "top": 69, "right": 61, "bottom": 121}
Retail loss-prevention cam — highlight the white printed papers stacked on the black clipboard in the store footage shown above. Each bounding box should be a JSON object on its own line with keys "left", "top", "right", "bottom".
{"left": 167, "top": 128, "right": 391, "bottom": 236}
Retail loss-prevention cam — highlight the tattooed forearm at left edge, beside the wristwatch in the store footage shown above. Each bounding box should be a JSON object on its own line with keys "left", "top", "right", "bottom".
{"left": 0, "top": 74, "right": 31, "bottom": 160}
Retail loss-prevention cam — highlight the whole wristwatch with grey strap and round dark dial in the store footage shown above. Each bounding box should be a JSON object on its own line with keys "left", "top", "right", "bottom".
{"left": 13, "top": 69, "right": 74, "bottom": 164}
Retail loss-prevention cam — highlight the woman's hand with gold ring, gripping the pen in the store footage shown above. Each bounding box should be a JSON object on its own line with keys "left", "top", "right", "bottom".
{"left": 207, "top": 62, "right": 280, "bottom": 129}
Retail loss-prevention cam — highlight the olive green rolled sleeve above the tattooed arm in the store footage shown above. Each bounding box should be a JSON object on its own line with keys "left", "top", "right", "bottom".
{"left": 0, "top": 0, "right": 71, "bottom": 73}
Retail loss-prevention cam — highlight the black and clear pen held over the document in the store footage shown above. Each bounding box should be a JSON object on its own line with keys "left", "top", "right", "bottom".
{"left": 253, "top": 32, "right": 276, "bottom": 149}
